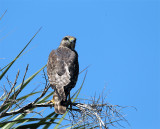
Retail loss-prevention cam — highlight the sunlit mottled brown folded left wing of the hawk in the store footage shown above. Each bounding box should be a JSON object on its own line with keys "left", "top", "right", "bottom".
{"left": 47, "top": 50, "right": 70, "bottom": 88}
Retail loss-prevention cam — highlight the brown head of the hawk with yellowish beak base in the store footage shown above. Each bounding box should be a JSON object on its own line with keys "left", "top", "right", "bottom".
{"left": 60, "top": 36, "right": 76, "bottom": 50}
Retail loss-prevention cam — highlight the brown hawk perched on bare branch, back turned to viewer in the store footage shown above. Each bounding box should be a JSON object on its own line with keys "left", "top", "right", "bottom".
{"left": 47, "top": 36, "right": 79, "bottom": 114}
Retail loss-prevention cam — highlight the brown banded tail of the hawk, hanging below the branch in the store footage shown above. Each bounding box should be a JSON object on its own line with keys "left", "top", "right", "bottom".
{"left": 53, "top": 94, "right": 67, "bottom": 114}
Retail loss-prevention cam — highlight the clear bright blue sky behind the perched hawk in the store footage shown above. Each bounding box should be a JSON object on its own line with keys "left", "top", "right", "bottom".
{"left": 0, "top": 0, "right": 160, "bottom": 129}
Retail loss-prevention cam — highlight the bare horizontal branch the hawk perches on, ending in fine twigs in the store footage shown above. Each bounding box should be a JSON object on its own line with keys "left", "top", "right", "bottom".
{"left": 0, "top": 97, "right": 134, "bottom": 129}
